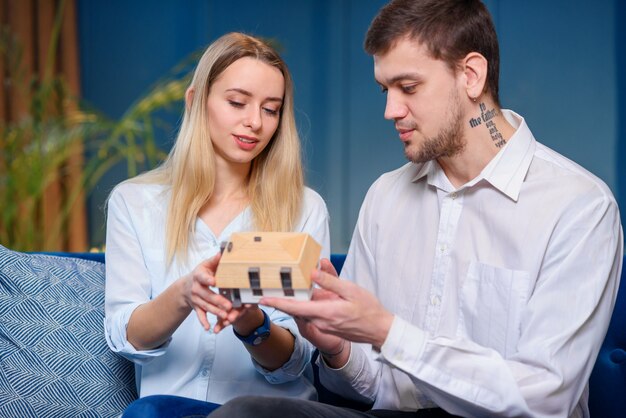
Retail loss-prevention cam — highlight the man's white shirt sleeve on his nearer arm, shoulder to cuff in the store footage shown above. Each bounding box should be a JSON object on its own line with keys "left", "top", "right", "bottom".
{"left": 378, "top": 191, "right": 623, "bottom": 417}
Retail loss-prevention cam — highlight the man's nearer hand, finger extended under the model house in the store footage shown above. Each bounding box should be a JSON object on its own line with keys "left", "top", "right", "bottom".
{"left": 260, "top": 260, "right": 393, "bottom": 353}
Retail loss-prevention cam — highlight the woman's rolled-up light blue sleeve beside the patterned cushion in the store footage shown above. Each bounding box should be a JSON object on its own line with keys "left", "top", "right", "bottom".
{"left": 104, "top": 185, "right": 169, "bottom": 364}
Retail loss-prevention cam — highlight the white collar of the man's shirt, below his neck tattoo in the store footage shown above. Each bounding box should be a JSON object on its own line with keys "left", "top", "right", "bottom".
{"left": 413, "top": 109, "right": 537, "bottom": 201}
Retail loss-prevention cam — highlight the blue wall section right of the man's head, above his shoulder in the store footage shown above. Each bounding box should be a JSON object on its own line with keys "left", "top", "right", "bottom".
{"left": 498, "top": 0, "right": 618, "bottom": 191}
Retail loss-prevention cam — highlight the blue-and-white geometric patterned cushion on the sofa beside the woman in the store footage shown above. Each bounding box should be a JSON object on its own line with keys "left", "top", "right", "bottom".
{"left": 0, "top": 246, "right": 136, "bottom": 418}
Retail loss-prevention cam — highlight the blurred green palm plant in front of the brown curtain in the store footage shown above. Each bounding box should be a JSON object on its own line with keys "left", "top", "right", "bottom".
{"left": 0, "top": 2, "right": 189, "bottom": 251}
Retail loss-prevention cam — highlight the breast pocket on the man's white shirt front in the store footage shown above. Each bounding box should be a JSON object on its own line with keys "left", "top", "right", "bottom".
{"left": 457, "top": 261, "right": 530, "bottom": 358}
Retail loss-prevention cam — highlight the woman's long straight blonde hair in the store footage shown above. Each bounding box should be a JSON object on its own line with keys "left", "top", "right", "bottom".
{"left": 133, "top": 33, "right": 304, "bottom": 264}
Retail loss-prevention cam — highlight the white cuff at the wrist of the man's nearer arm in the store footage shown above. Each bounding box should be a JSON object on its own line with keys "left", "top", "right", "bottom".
{"left": 376, "top": 316, "right": 428, "bottom": 370}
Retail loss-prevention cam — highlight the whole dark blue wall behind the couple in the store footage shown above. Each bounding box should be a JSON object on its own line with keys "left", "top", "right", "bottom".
{"left": 78, "top": 0, "right": 626, "bottom": 251}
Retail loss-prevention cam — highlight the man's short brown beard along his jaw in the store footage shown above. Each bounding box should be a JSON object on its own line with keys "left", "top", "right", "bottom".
{"left": 405, "top": 90, "right": 466, "bottom": 163}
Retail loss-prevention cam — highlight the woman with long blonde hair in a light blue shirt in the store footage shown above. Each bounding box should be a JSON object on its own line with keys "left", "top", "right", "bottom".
{"left": 105, "top": 33, "right": 329, "bottom": 414}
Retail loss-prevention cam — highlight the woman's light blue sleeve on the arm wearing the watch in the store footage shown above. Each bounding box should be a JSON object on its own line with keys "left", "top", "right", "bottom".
{"left": 252, "top": 188, "right": 330, "bottom": 383}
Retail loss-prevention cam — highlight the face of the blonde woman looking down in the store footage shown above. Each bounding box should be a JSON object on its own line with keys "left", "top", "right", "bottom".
{"left": 207, "top": 57, "right": 285, "bottom": 169}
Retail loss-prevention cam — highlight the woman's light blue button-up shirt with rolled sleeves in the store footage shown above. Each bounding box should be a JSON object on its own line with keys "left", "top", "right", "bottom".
{"left": 105, "top": 182, "right": 330, "bottom": 404}
